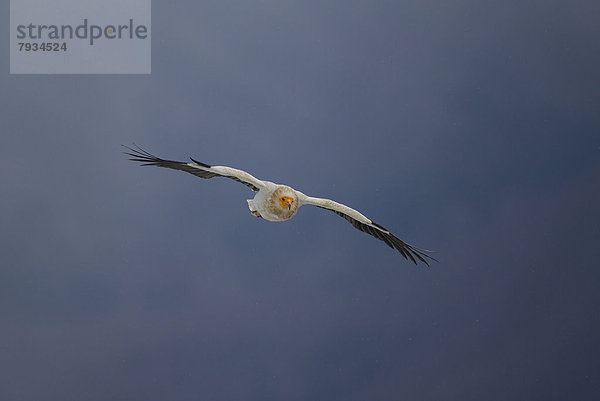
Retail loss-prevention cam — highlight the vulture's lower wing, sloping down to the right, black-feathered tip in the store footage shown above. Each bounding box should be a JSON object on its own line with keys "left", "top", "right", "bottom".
{"left": 302, "top": 196, "right": 437, "bottom": 266}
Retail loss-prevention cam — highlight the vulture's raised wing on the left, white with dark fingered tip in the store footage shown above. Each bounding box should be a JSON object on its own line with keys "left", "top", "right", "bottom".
{"left": 122, "top": 145, "right": 264, "bottom": 192}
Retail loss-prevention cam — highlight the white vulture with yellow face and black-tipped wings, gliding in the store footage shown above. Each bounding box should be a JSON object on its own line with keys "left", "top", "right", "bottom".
{"left": 122, "top": 145, "right": 437, "bottom": 266}
